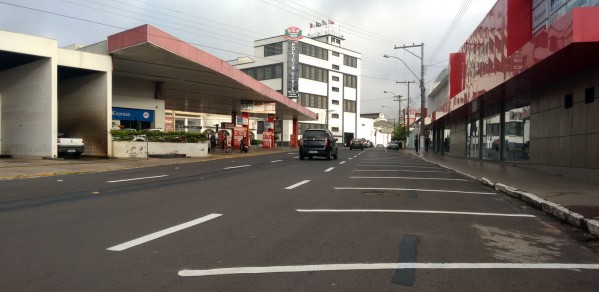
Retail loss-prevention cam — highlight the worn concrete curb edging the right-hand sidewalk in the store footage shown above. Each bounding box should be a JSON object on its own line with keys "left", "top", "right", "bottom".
{"left": 423, "top": 158, "right": 599, "bottom": 238}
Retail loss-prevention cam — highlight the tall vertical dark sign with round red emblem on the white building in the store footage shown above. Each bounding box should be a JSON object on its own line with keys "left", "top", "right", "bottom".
{"left": 283, "top": 26, "right": 303, "bottom": 100}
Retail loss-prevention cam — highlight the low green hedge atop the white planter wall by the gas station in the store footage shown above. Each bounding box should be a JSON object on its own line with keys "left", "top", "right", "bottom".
{"left": 110, "top": 130, "right": 208, "bottom": 143}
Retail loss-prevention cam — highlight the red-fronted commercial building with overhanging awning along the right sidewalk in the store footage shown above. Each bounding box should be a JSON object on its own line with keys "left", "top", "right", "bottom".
{"left": 428, "top": 0, "right": 599, "bottom": 178}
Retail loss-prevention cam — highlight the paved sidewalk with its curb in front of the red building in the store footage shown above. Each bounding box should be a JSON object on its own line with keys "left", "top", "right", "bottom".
{"left": 410, "top": 150, "right": 599, "bottom": 237}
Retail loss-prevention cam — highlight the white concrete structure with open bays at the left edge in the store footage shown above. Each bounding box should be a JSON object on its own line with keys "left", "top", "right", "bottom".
{"left": 0, "top": 31, "right": 112, "bottom": 157}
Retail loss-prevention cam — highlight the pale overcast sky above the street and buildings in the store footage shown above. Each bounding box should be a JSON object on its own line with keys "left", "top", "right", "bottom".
{"left": 0, "top": 0, "right": 496, "bottom": 117}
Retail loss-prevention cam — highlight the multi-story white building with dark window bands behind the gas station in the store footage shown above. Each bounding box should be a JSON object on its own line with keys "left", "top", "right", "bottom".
{"left": 230, "top": 27, "right": 361, "bottom": 144}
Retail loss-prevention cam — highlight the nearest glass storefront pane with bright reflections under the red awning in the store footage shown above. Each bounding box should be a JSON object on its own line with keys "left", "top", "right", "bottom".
{"left": 503, "top": 100, "right": 530, "bottom": 161}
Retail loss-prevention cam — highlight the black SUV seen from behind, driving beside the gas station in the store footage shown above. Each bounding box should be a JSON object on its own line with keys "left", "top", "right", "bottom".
{"left": 299, "top": 129, "right": 339, "bottom": 160}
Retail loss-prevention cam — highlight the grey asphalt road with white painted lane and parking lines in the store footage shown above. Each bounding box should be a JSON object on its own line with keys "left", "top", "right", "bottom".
{"left": 0, "top": 148, "right": 599, "bottom": 291}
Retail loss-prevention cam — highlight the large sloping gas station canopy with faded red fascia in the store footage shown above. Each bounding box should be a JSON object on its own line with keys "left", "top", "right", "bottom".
{"left": 108, "top": 25, "right": 317, "bottom": 121}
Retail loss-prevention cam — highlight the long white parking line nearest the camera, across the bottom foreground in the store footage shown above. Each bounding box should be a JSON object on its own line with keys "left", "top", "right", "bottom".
{"left": 179, "top": 263, "right": 599, "bottom": 277}
